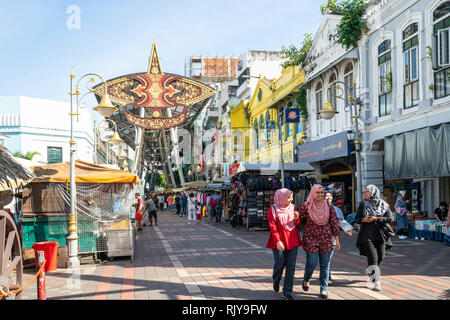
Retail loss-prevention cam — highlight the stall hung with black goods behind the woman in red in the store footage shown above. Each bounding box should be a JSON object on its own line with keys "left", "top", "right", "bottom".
{"left": 228, "top": 163, "right": 315, "bottom": 230}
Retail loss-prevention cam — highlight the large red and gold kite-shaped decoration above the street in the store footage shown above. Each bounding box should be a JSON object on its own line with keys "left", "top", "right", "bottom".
{"left": 93, "top": 43, "right": 215, "bottom": 130}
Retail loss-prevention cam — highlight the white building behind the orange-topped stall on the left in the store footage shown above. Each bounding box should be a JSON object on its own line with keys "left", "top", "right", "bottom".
{"left": 0, "top": 96, "right": 94, "bottom": 163}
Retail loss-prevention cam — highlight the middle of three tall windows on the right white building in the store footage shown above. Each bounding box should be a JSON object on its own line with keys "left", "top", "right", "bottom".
{"left": 403, "top": 23, "right": 419, "bottom": 109}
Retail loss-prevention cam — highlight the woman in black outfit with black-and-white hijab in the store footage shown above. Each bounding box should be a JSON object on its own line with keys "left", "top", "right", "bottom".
{"left": 355, "top": 185, "right": 392, "bottom": 291}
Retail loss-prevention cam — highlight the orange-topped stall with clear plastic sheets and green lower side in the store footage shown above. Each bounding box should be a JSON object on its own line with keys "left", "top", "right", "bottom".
{"left": 23, "top": 160, "right": 138, "bottom": 258}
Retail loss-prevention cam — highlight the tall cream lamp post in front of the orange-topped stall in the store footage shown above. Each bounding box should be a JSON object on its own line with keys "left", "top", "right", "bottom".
{"left": 67, "top": 67, "right": 118, "bottom": 269}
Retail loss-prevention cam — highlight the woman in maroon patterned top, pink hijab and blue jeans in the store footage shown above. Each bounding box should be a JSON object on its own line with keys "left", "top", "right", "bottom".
{"left": 300, "top": 184, "right": 341, "bottom": 299}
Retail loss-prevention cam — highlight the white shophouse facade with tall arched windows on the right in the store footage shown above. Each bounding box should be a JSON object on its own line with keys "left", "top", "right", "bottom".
{"left": 298, "top": 0, "right": 450, "bottom": 217}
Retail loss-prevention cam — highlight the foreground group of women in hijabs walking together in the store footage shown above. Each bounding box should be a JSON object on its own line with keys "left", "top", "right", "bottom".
{"left": 266, "top": 184, "right": 394, "bottom": 300}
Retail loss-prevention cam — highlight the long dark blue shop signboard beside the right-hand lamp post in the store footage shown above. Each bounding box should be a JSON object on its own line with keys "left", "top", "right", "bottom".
{"left": 298, "top": 131, "right": 352, "bottom": 162}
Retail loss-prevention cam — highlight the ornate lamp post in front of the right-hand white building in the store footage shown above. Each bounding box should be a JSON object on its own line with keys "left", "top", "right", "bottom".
{"left": 319, "top": 79, "right": 362, "bottom": 203}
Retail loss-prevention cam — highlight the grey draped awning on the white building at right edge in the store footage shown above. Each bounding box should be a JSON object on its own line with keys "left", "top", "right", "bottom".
{"left": 384, "top": 123, "right": 450, "bottom": 180}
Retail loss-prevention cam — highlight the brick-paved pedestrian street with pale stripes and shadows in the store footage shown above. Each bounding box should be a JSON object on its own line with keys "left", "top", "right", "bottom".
{"left": 14, "top": 212, "right": 450, "bottom": 300}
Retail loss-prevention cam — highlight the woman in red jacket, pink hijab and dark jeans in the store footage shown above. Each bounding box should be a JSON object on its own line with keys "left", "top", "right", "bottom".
{"left": 266, "top": 189, "right": 302, "bottom": 300}
